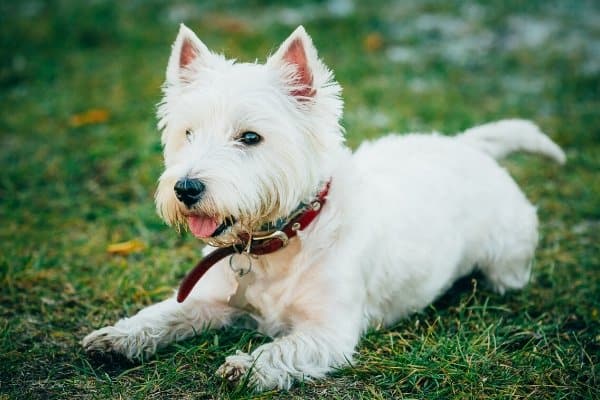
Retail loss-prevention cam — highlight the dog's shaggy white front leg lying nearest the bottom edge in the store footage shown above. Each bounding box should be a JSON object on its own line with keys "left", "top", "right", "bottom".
{"left": 217, "top": 321, "right": 360, "bottom": 391}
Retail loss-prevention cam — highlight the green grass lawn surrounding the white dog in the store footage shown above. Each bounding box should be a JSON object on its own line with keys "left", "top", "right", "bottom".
{"left": 0, "top": 0, "right": 600, "bottom": 399}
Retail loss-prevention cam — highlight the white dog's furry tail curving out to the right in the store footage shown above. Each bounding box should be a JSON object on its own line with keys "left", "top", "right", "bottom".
{"left": 456, "top": 119, "right": 567, "bottom": 164}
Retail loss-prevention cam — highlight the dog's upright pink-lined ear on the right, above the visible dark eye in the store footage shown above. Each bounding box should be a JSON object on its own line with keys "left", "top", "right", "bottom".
{"left": 267, "top": 26, "right": 321, "bottom": 100}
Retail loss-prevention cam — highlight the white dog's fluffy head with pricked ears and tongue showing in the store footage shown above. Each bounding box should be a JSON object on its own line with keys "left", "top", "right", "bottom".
{"left": 156, "top": 25, "right": 343, "bottom": 243}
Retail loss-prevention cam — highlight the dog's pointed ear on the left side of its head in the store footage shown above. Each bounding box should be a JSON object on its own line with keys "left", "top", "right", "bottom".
{"left": 167, "top": 24, "right": 211, "bottom": 85}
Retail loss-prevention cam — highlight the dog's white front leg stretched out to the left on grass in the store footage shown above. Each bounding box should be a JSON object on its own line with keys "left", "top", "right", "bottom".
{"left": 81, "top": 265, "right": 238, "bottom": 360}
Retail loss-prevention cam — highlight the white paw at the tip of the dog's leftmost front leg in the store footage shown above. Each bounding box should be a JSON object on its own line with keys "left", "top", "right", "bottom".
{"left": 81, "top": 326, "right": 156, "bottom": 360}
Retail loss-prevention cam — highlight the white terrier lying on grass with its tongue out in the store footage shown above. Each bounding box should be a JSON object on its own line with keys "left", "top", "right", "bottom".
{"left": 82, "top": 25, "right": 565, "bottom": 390}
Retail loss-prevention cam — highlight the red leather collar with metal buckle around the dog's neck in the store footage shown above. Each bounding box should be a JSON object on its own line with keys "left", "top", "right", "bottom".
{"left": 177, "top": 181, "right": 331, "bottom": 303}
